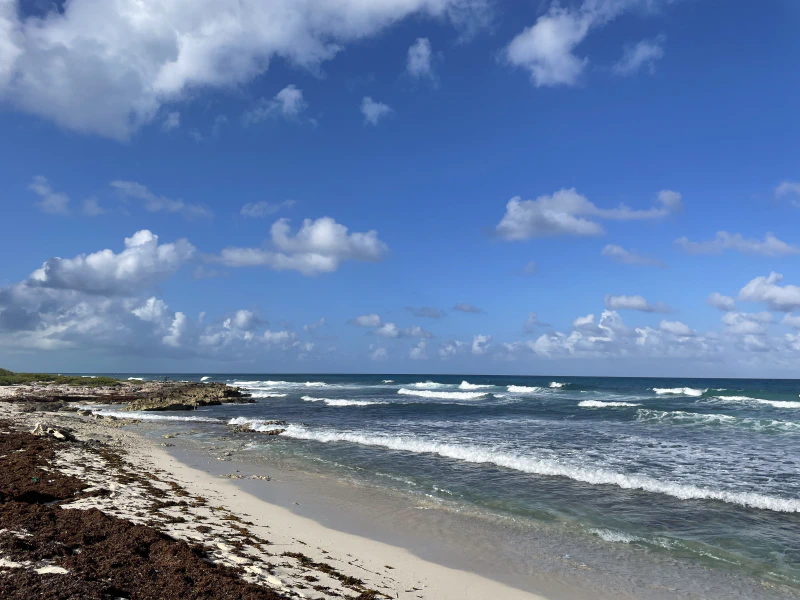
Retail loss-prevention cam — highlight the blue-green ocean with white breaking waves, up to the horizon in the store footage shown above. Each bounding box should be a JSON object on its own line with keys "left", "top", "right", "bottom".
{"left": 94, "top": 374, "right": 800, "bottom": 590}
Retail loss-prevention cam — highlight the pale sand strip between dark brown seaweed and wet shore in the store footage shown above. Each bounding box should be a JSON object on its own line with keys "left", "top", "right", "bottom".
{"left": 0, "top": 403, "right": 547, "bottom": 600}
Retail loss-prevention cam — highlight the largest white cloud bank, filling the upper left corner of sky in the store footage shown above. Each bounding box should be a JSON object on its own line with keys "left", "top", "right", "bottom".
{"left": 0, "top": 0, "right": 488, "bottom": 140}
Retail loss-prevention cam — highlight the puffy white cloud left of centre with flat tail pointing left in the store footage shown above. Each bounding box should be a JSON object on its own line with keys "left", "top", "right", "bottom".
{"left": 217, "top": 217, "right": 389, "bottom": 275}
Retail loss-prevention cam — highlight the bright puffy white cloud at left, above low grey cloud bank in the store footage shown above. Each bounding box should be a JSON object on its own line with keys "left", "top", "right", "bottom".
{"left": 29, "top": 229, "right": 195, "bottom": 295}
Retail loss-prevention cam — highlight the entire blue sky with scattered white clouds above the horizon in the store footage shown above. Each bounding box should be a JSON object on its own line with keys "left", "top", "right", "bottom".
{"left": 0, "top": 0, "right": 800, "bottom": 377}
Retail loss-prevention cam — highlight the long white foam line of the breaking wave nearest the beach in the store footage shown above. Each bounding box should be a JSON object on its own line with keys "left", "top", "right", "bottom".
{"left": 282, "top": 425, "right": 800, "bottom": 513}
